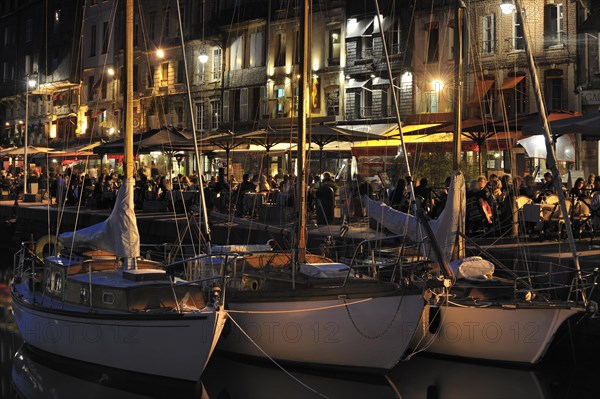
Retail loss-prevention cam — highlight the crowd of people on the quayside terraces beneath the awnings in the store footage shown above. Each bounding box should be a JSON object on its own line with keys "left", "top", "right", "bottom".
{"left": 0, "top": 168, "right": 600, "bottom": 238}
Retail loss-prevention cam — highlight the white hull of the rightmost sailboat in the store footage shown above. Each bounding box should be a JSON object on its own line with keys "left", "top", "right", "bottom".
{"left": 411, "top": 305, "right": 585, "bottom": 364}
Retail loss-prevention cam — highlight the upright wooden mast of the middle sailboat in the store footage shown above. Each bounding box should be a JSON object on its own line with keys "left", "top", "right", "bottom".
{"left": 292, "top": 0, "right": 311, "bottom": 267}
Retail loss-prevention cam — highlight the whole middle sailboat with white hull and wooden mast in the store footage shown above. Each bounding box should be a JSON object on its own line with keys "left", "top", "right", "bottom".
{"left": 213, "top": 0, "right": 424, "bottom": 372}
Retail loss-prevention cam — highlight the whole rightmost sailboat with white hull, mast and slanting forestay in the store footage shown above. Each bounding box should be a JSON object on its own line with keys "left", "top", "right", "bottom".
{"left": 365, "top": 1, "right": 597, "bottom": 364}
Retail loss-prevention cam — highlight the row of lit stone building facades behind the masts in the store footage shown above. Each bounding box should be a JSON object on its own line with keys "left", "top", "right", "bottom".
{"left": 0, "top": 0, "right": 600, "bottom": 178}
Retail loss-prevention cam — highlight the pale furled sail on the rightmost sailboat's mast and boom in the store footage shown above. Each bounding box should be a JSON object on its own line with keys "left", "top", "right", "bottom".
{"left": 365, "top": 172, "right": 467, "bottom": 261}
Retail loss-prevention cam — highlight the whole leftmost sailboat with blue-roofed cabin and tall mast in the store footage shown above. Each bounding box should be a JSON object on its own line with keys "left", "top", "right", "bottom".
{"left": 11, "top": 0, "right": 225, "bottom": 381}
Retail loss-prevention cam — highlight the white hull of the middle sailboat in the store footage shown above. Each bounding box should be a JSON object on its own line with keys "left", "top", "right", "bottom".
{"left": 218, "top": 294, "right": 423, "bottom": 371}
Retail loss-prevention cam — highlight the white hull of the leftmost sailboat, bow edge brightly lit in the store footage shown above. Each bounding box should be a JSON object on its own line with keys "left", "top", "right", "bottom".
{"left": 13, "top": 297, "right": 225, "bottom": 381}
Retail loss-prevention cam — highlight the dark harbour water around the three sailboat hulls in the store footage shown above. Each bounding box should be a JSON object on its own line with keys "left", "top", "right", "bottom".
{"left": 0, "top": 245, "right": 600, "bottom": 399}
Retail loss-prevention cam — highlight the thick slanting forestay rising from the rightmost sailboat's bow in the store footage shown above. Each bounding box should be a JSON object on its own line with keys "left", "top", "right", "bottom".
{"left": 515, "top": 0, "right": 587, "bottom": 305}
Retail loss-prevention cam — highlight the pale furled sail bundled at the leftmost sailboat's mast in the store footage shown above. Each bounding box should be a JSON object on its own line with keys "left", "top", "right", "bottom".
{"left": 58, "top": 178, "right": 140, "bottom": 258}
